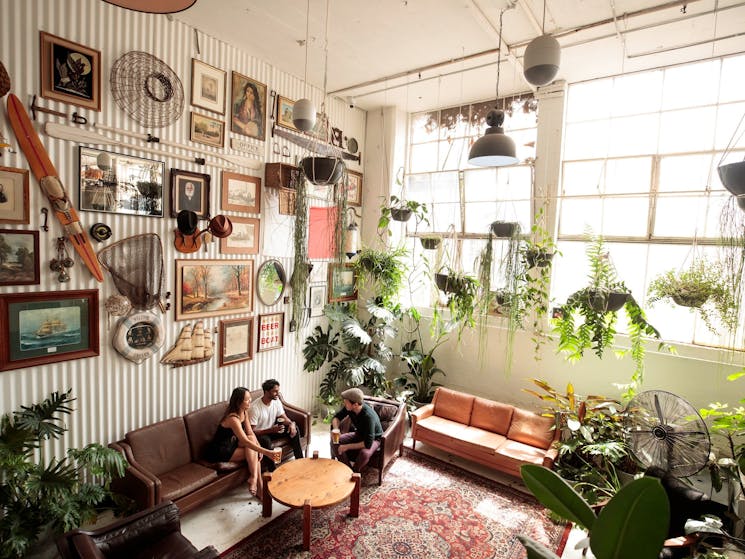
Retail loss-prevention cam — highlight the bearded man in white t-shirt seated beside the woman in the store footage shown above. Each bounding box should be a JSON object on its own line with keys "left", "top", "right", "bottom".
{"left": 249, "top": 378, "right": 303, "bottom": 472}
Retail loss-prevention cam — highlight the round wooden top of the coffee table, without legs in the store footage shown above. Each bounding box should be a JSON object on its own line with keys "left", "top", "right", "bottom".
{"left": 267, "top": 458, "right": 355, "bottom": 509}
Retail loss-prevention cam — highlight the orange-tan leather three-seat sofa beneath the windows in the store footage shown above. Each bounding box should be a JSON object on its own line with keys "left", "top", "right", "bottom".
{"left": 411, "top": 387, "right": 560, "bottom": 477}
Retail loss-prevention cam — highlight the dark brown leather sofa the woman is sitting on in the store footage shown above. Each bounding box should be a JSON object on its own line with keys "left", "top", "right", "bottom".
{"left": 109, "top": 390, "right": 311, "bottom": 514}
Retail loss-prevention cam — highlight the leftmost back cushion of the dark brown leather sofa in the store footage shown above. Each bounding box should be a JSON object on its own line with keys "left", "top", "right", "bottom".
{"left": 125, "top": 417, "right": 191, "bottom": 476}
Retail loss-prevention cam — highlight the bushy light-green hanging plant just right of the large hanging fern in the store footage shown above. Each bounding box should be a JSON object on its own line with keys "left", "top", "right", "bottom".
{"left": 649, "top": 258, "right": 738, "bottom": 334}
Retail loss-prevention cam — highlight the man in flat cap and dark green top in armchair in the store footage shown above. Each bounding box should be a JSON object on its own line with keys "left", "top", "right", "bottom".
{"left": 331, "top": 388, "right": 383, "bottom": 472}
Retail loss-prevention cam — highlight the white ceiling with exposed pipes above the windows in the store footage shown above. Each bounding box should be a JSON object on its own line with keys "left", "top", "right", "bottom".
{"left": 174, "top": 0, "right": 745, "bottom": 112}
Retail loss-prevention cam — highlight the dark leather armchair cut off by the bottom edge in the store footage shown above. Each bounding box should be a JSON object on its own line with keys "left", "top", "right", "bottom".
{"left": 56, "top": 501, "right": 219, "bottom": 559}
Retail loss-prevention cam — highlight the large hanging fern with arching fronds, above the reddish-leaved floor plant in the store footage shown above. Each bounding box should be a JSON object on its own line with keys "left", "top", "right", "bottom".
{"left": 552, "top": 236, "right": 669, "bottom": 398}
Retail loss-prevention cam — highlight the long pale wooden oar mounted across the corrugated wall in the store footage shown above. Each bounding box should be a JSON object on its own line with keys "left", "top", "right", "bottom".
{"left": 44, "top": 122, "right": 262, "bottom": 169}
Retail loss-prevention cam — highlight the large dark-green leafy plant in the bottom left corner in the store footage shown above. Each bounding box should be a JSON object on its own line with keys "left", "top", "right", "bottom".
{"left": 0, "top": 390, "right": 127, "bottom": 558}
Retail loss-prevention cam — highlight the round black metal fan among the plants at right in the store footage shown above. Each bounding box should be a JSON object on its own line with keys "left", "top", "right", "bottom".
{"left": 624, "top": 390, "right": 711, "bottom": 477}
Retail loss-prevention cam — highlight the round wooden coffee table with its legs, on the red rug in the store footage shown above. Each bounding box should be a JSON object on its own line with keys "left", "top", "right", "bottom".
{"left": 261, "top": 451, "right": 360, "bottom": 551}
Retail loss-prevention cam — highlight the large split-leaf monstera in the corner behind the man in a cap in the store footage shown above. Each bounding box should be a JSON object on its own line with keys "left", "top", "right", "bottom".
{"left": 303, "top": 299, "right": 400, "bottom": 404}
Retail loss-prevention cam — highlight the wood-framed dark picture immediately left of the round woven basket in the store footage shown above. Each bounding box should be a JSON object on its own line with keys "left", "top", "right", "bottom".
{"left": 39, "top": 31, "right": 101, "bottom": 111}
